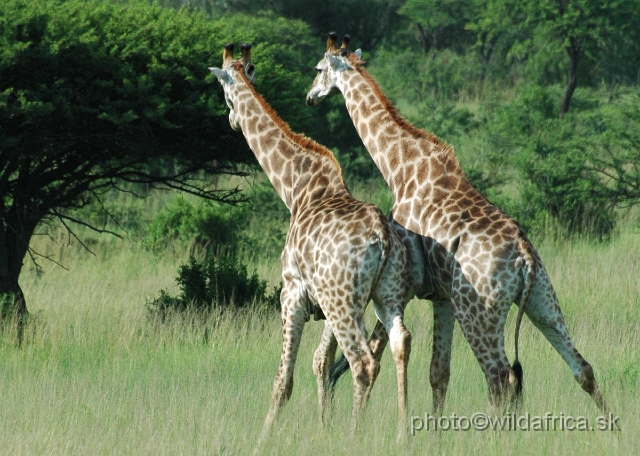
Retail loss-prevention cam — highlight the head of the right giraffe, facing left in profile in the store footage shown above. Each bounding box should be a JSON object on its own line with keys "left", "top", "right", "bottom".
{"left": 306, "top": 32, "right": 363, "bottom": 106}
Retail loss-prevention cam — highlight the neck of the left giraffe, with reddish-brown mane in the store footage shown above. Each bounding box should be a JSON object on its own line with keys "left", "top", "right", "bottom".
{"left": 232, "top": 66, "right": 348, "bottom": 215}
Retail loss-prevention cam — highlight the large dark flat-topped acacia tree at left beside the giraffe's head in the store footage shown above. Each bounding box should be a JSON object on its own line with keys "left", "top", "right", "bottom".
{"left": 0, "top": 0, "right": 316, "bottom": 324}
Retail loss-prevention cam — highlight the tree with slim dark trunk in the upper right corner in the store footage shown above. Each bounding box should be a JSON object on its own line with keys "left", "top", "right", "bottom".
{"left": 468, "top": 0, "right": 640, "bottom": 119}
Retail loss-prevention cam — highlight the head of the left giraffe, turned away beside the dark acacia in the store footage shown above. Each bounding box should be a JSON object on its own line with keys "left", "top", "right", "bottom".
{"left": 209, "top": 43, "right": 256, "bottom": 131}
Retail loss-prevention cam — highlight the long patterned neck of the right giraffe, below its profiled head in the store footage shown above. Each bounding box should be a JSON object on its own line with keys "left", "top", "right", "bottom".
{"left": 341, "top": 68, "right": 479, "bottom": 234}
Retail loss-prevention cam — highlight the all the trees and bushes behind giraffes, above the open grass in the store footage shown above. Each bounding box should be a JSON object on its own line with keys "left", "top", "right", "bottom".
{"left": 0, "top": 0, "right": 640, "bottom": 320}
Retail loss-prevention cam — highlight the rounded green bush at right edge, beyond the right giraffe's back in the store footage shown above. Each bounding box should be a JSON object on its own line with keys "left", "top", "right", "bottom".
{"left": 488, "top": 86, "right": 640, "bottom": 241}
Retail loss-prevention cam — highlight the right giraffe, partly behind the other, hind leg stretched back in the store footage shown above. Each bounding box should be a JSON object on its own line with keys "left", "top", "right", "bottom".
{"left": 306, "top": 33, "right": 608, "bottom": 413}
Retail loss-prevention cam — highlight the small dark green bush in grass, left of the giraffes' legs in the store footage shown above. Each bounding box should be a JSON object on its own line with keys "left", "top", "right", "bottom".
{"left": 148, "top": 257, "right": 282, "bottom": 318}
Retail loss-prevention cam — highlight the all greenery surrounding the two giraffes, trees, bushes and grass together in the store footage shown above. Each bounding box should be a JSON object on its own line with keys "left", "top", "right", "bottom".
{"left": 0, "top": 0, "right": 640, "bottom": 454}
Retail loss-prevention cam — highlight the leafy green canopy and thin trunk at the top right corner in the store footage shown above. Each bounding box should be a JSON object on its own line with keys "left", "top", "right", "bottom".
{"left": 467, "top": 0, "right": 640, "bottom": 118}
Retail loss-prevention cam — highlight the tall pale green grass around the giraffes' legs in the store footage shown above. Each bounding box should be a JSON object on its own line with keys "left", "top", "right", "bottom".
{"left": 0, "top": 220, "right": 640, "bottom": 455}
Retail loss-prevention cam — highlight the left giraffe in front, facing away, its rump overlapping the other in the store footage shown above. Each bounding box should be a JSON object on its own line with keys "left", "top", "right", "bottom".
{"left": 210, "top": 44, "right": 411, "bottom": 442}
